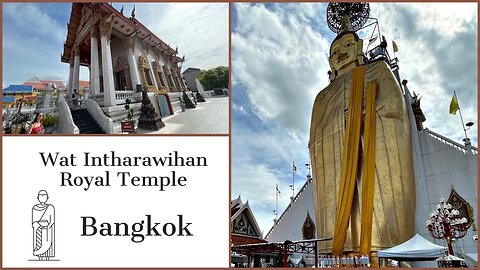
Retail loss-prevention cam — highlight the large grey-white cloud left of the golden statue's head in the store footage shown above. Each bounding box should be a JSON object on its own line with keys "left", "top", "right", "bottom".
{"left": 232, "top": 4, "right": 329, "bottom": 136}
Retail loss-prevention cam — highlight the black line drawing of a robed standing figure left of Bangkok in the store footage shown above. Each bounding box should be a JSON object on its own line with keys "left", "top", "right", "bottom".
{"left": 32, "top": 190, "right": 55, "bottom": 261}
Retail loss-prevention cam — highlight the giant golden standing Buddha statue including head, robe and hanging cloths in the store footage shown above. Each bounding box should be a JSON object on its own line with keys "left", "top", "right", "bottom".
{"left": 309, "top": 22, "right": 415, "bottom": 254}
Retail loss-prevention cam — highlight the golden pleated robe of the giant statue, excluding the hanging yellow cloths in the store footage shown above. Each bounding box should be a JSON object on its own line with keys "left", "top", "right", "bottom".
{"left": 310, "top": 61, "right": 415, "bottom": 253}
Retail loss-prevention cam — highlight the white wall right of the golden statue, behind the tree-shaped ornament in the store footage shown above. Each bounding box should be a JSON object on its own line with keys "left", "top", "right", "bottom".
{"left": 415, "top": 130, "right": 478, "bottom": 260}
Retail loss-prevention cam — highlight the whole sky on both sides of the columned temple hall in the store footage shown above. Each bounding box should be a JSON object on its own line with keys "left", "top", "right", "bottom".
{"left": 2, "top": 3, "right": 228, "bottom": 87}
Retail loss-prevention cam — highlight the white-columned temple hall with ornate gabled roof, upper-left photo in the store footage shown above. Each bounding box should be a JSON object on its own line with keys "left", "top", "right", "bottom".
{"left": 59, "top": 3, "right": 191, "bottom": 133}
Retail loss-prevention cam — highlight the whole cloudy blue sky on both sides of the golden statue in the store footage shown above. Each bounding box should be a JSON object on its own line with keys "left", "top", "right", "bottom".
{"left": 232, "top": 3, "right": 478, "bottom": 236}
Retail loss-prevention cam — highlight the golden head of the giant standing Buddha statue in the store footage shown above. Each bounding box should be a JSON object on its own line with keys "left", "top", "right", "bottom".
{"left": 328, "top": 16, "right": 363, "bottom": 79}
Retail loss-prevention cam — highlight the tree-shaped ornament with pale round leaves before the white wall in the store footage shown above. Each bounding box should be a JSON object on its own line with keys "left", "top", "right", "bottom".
{"left": 427, "top": 198, "right": 467, "bottom": 255}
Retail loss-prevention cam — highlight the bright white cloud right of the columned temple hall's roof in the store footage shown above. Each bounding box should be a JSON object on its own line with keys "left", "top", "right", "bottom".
{"left": 136, "top": 3, "right": 229, "bottom": 69}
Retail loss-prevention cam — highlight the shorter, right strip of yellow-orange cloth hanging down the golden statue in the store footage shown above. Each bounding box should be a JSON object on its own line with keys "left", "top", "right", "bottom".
{"left": 359, "top": 81, "right": 377, "bottom": 255}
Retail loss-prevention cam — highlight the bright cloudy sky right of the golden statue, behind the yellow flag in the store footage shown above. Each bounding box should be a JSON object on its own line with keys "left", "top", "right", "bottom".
{"left": 372, "top": 3, "right": 478, "bottom": 145}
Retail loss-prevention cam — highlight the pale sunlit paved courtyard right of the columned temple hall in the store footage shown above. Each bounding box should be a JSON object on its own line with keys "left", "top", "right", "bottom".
{"left": 137, "top": 97, "right": 229, "bottom": 134}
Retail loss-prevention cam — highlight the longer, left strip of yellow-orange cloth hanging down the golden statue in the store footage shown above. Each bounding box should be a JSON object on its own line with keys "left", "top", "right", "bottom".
{"left": 332, "top": 66, "right": 365, "bottom": 254}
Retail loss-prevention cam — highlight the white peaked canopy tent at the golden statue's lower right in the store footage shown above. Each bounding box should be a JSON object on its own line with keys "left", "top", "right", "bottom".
{"left": 378, "top": 234, "right": 447, "bottom": 261}
